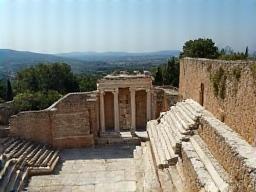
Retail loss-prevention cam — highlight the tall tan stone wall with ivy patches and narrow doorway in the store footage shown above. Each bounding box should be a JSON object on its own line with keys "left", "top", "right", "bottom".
{"left": 179, "top": 58, "right": 256, "bottom": 145}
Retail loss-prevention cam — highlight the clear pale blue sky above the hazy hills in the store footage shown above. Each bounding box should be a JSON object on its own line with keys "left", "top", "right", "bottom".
{"left": 0, "top": 0, "right": 256, "bottom": 53}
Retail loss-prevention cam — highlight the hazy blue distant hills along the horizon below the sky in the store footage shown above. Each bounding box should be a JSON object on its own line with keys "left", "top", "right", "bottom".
{"left": 0, "top": 49, "right": 179, "bottom": 77}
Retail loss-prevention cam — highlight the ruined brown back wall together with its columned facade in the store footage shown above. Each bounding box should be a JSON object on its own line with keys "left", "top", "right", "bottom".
{"left": 6, "top": 73, "right": 178, "bottom": 148}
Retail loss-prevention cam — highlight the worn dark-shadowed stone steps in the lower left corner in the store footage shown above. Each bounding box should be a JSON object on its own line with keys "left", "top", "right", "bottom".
{"left": 0, "top": 137, "right": 59, "bottom": 192}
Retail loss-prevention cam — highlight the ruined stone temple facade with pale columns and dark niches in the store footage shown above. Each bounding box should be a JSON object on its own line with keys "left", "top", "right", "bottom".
{"left": 98, "top": 74, "right": 155, "bottom": 134}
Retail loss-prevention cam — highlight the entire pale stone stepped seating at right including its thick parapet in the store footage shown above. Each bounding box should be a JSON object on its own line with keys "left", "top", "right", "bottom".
{"left": 147, "top": 99, "right": 256, "bottom": 192}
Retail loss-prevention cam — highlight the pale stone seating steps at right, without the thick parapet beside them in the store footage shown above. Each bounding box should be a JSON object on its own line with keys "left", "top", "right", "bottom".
{"left": 147, "top": 99, "right": 246, "bottom": 192}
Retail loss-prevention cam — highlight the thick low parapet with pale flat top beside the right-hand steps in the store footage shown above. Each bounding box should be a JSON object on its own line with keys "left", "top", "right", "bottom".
{"left": 198, "top": 111, "right": 256, "bottom": 192}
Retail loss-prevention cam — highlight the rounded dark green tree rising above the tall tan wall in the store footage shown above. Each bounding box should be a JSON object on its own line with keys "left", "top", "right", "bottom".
{"left": 180, "top": 38, "right": 219, "bottom": 59}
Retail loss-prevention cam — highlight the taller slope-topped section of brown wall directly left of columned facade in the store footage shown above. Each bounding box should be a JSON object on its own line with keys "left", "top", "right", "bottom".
{"left": 49, "top": 93, "right": 97, "bottom": 148}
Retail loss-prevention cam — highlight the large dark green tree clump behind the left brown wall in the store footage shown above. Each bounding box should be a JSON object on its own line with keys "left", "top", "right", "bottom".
{"left": 16, "top": 63, "right": 79, "bottom": 94}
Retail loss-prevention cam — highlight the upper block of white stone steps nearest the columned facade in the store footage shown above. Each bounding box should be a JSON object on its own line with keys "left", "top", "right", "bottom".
{"left": 147, "top": 100, "right": 203, "bottom": 169}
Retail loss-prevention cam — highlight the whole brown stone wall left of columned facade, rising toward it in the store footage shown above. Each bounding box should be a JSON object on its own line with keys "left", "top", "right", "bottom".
{"left": 10, "top": 92, "right": 98, "bottom": 148}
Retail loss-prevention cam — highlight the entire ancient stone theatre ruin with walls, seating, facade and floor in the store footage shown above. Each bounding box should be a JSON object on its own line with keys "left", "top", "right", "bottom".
{"left": 0, "top": 58, "right": 256, "bottom": 192}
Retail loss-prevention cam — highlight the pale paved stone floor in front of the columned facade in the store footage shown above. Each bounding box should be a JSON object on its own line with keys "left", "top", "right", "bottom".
{"left": 27, "top": 145, "right": 137, "bottom": 192}
